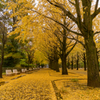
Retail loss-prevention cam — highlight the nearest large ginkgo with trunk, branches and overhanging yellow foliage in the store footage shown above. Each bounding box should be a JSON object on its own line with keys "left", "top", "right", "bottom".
{"left": 4, "top": 0, "right": 100, "bottom": 87}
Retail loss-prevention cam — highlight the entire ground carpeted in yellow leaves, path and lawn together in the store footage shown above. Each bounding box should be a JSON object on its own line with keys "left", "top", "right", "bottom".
{"left": 0, "top": 69, "right": 100, "bottom": 100}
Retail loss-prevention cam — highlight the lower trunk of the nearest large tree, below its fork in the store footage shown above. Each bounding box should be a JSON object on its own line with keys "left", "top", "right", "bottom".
{"left": 85, "top": 35, "right": 100, "bottom": 87}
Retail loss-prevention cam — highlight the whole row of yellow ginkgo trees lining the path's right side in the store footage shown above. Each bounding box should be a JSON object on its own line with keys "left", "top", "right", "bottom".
{"left": 1, "top": 0, "right": 100, "bottom": 87}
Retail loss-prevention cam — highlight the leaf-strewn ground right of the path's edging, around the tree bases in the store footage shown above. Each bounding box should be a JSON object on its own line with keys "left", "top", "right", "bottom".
{"left": 51, "top": 69, "right": 100, "bottom": 100}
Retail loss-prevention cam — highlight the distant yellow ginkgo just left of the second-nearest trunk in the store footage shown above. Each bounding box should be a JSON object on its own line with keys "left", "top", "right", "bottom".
{"left": 38, "top": 27, "right": 59, "bottom": 72}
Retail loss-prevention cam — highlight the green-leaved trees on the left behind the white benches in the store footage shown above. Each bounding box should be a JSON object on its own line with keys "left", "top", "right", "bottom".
{"left": 0, "top": 0, "right": 47, "bottom": 78}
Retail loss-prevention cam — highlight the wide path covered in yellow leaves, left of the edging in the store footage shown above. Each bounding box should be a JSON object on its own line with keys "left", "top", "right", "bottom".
{"left": 0, "top": 69, "right": 55, "bottom": 100}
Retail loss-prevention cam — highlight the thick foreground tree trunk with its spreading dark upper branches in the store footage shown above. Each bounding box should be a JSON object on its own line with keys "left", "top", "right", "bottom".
{"left": 35, "top": 0, "right": 100, "bottom": 87}
